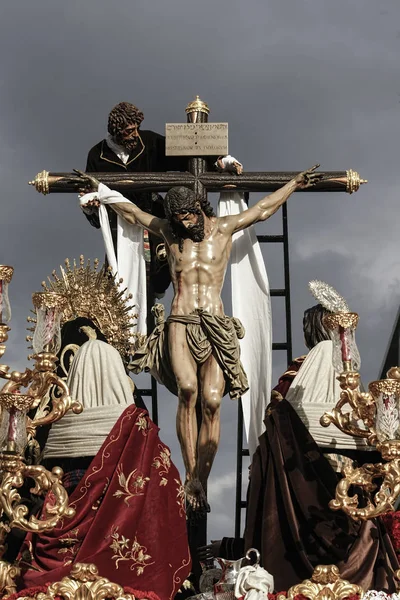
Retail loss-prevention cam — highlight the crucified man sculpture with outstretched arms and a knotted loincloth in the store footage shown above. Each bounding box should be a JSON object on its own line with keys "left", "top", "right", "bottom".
{"left": 77, "top": 165, "right": 322, "bottom": 513}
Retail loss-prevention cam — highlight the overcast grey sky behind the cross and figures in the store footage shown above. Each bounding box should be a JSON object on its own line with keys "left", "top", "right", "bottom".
{"left": 0, "top": 0, "right": 400, "bottom": 537}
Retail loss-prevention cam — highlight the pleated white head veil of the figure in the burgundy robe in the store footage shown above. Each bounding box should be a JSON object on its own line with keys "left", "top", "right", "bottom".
{"left": 44, "top": 340, "right": 133, "bottom": 458}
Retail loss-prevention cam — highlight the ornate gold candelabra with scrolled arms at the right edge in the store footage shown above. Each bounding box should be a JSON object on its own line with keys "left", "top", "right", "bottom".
{"left": 320, "top": 312, "right": 400, "bottom": 520}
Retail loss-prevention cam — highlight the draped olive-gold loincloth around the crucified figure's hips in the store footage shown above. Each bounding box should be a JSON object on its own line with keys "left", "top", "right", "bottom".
{"left": 128, "top": 304, "right": 249, "bottom": 399}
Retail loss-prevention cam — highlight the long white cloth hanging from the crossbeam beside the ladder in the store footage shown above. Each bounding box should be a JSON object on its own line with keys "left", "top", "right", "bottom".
{"left": 218, "top": 192, "right": 272, "bottom": 456}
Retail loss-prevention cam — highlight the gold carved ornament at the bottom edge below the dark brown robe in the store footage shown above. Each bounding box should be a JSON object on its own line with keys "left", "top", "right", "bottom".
{"left": 277, "top": 565, "right": 364, "bottom": 600}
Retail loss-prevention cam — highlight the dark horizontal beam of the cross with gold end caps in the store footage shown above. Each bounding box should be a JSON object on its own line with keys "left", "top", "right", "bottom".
{"left": 29, "top": 168, "right": 367, "bottom": 194}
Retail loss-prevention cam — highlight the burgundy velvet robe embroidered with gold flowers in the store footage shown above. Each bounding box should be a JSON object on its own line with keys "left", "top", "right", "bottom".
{"left": 21, "top": 405, "right": 191, "bottom": 600}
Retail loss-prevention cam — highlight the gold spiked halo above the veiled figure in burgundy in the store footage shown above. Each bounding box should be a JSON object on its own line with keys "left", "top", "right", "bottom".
{"left": 36, "top": 256, "right": 139, "bottom": 359}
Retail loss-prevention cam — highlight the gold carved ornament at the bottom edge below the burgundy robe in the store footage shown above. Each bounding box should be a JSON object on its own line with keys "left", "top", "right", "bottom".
{"left": 31, "top": 563, "right": 135, "bottom": 600}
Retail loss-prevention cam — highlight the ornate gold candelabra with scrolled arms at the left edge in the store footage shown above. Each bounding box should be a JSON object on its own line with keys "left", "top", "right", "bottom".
{"left": 0, "top": 265, "right": 82, "bottom": 592}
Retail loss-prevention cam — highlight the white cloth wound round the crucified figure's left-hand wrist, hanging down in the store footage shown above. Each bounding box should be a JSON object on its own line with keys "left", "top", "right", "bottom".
{"left": 80, "top": 183, "right": 147, "bottom": 335}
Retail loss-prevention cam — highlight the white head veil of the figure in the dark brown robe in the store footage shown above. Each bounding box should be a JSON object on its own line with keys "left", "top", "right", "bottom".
{"left": 286, "top": 340, "right": 371, "bottom": 450}
